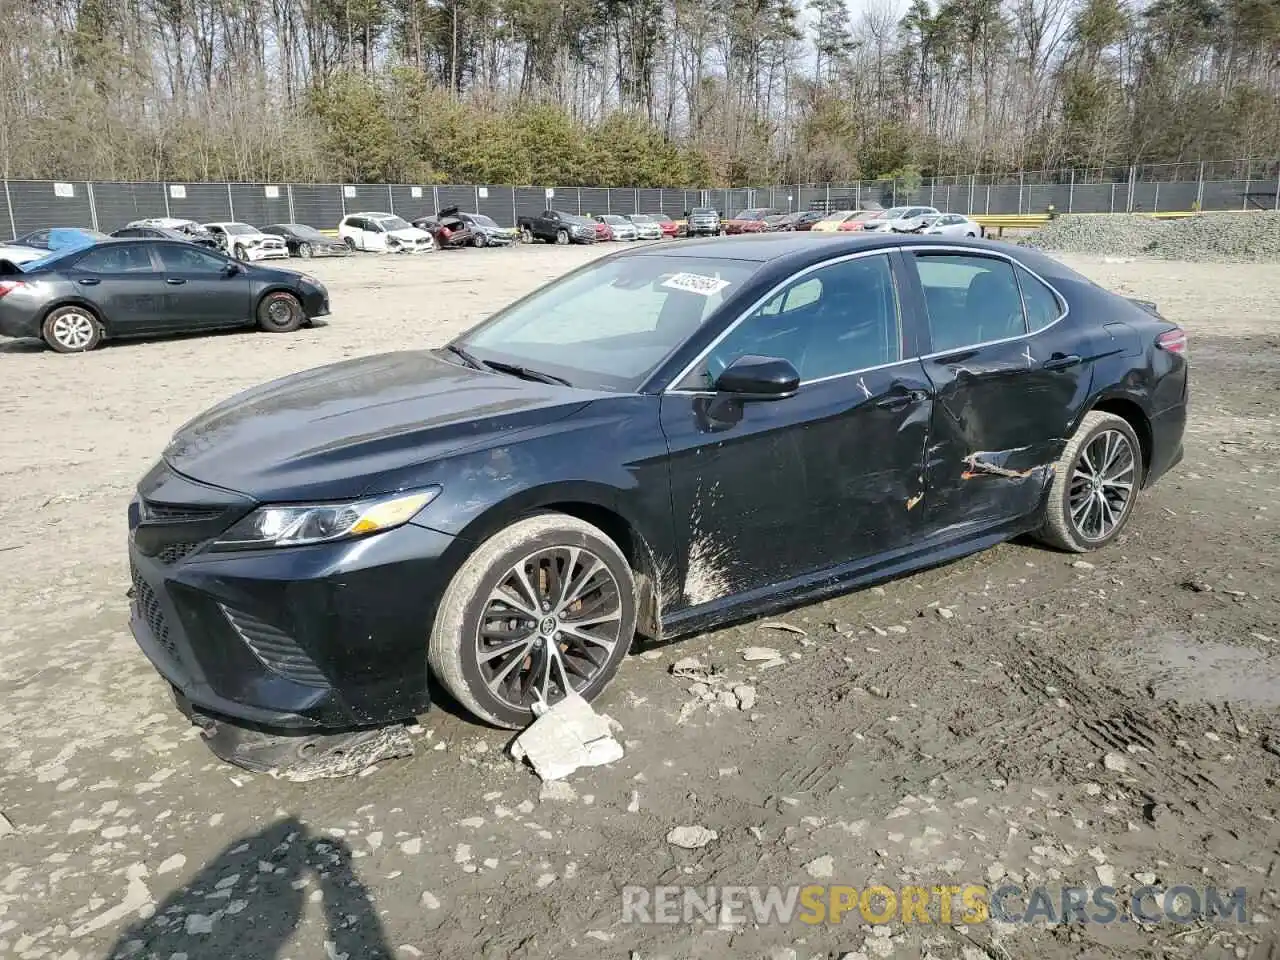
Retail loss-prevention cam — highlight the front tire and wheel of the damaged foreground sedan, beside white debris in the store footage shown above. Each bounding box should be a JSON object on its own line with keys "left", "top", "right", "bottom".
{"left": 428, "top": 513, "right": 636, "bottom": 730}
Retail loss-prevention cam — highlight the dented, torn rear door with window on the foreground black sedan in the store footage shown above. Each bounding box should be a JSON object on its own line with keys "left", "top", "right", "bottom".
{"left": 908, "top": 248, "right": 1092, "bottom": 532}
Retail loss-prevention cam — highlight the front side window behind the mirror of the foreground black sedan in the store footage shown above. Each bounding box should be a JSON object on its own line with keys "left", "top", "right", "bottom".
{"left": 682, "top": 256, "right": 902, "bottom": 389}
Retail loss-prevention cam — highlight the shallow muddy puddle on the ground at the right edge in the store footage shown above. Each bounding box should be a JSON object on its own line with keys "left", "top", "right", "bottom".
{"left": 1124, "top": 634, "right": 1280, "bottom": 707}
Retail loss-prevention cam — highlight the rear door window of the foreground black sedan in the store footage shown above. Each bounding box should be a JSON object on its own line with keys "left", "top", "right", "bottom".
{"left": 915, "top": 253, "right": 1027, "bottom": 352}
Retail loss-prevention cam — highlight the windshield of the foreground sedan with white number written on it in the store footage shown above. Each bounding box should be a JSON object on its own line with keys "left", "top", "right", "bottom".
{"left": 458, "top": 256, "right": 758, "bottom": 392}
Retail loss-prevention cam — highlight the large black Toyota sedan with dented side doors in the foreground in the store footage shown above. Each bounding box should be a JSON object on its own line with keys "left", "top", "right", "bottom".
{"left": 128, "top": 233, "right": 1188, "bottom": 730}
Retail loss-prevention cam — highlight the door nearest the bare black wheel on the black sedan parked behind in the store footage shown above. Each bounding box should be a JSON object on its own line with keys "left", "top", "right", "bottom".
{"left": 156, "top": 242, "right": 252, "bottom": 329}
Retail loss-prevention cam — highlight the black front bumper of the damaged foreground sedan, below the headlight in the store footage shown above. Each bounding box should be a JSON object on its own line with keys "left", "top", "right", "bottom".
{"left": 129, "top": 471, "right": 456, "bottom": 731}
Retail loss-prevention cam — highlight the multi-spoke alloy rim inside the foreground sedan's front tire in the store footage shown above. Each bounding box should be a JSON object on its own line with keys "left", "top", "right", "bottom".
{"left": 476, "top": 547, "right": 622, "bottom": 709}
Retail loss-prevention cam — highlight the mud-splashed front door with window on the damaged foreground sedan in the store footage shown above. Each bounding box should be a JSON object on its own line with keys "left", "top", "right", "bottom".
{"left": 662, "top": 253, "right": 932, "bottom": 605}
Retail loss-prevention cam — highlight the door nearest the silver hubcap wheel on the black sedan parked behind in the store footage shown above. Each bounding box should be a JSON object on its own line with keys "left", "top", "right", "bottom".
{"left": 67, "top": 242, "right": 168, "bottom": 337}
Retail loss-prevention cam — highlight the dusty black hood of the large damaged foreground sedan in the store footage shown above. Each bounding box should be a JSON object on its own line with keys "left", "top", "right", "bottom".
{"left": 164, "top": 351, "right": 591, "bottom": 502}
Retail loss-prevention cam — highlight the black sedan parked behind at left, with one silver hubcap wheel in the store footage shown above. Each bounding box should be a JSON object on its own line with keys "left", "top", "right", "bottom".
{"left": 0, "top": 239, "right": 329, "bottom": 353}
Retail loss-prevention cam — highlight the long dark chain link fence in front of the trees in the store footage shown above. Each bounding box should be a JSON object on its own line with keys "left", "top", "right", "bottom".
{"left": 4, "top": 160, "right": 1280, "bottom": 237}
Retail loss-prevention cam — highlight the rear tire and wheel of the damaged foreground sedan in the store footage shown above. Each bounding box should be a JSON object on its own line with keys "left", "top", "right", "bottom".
{"left": 1036, "top": 411, "right": 1143, "bottom": 553}
